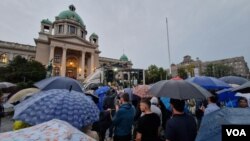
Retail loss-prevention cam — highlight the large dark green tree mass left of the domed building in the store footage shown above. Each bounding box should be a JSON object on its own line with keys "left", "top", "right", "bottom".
{"left": 0, "top": 56, "right": 46, "bottom": 87}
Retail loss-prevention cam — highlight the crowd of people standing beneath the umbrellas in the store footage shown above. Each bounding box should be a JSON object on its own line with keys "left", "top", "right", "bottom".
{"left": 85, "top": 88, "right": 248, "bottom": 141}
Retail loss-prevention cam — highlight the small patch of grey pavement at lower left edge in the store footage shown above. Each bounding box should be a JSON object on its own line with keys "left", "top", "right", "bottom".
{"left": 0, "top": 115, "right": 13, "bottom": 133}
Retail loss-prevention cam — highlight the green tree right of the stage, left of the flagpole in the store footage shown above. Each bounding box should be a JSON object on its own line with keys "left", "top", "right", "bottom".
{"left": 145, "top": 65, "right": 166, "bottom": 84}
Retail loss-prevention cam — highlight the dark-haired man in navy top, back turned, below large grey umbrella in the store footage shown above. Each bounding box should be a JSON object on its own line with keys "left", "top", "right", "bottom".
{"left": 165, "top": 98, "right": 197, "bottom": 141}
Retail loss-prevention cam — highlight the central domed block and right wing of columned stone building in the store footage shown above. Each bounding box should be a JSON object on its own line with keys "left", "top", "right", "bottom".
{"left": 35, "top": 5, "right": 132, "bottom": 79}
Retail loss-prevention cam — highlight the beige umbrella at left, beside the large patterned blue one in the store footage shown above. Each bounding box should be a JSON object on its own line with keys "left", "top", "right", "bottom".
{"left": 8, "top": 88, "right": 39, "bottom": 103}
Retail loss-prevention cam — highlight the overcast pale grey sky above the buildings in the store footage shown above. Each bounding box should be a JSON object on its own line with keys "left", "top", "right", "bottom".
{"left": 0, "top": 0, "right": 250, "bottom": 68}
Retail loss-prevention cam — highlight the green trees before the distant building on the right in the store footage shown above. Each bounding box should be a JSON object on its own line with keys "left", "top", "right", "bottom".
{"left": 205, "top": 64, "right": 233, "bottom": 78}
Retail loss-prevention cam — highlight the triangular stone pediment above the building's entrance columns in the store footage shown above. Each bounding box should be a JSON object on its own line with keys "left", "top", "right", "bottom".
{"left": 50, "top": 36, "right": 96, "bottom": 48}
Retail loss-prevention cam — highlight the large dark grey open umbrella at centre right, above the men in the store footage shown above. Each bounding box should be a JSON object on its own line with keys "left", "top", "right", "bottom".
{"left": 149, "top": 80, "right": 212, "bottom": 99}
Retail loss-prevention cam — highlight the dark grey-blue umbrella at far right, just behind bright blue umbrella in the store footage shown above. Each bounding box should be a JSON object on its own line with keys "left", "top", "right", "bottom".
{"left": 219, "top": 76, "right": 248, "bottom": 85}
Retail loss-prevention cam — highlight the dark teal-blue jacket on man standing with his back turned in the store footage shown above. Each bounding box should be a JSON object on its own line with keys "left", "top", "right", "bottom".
{"left": 113, "top": 103, "right": 135, "bottom": 136}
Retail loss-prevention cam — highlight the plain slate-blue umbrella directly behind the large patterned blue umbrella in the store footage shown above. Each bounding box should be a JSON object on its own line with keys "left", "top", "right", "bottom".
{"left": 34, "top": 76, "right": 83, "bottom": 92}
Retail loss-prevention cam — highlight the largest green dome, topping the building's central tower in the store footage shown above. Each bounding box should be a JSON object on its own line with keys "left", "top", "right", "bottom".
{"left": 57, "top": 5, "right": 84, "bottom": 26}
